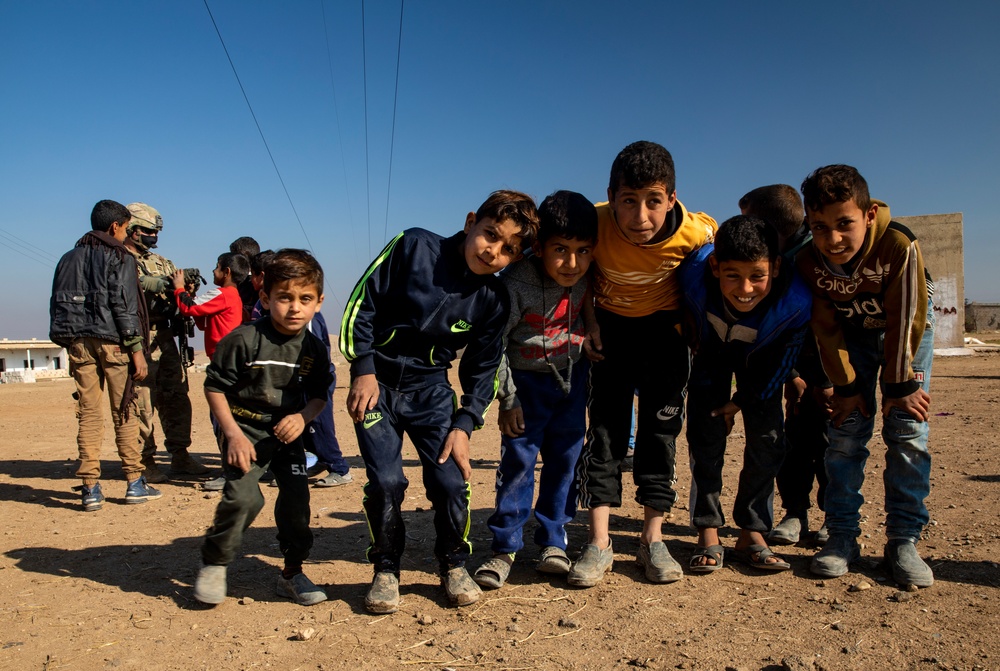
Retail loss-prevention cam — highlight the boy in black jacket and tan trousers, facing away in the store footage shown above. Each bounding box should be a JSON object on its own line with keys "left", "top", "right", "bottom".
{"left": 49, "top": 200, "right": 160, "bottom": 511}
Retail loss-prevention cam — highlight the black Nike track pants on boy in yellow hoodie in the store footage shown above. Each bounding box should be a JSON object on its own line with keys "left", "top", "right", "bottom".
{"left": 577, "top": 309, "right": 690, "bottom": 512}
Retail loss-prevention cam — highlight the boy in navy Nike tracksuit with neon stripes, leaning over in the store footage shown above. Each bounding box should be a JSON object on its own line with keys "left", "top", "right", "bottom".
{"left": 340, "top": 191, "right": 538, "bottom": 613}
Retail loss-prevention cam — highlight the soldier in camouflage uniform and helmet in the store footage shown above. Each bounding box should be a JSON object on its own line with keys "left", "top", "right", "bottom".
{"left": 125, "top": 203, "right": 208, "bottom": 482}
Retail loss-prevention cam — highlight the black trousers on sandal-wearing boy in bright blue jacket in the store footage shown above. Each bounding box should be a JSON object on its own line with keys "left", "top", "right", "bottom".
{"left": 687, "top": 352, "right": 785, "bottom": 533}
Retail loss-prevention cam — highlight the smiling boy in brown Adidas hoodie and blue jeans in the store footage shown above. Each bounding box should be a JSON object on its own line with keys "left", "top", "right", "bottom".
{"left": 796, "top": 165, "right": 934, "bottom": 587}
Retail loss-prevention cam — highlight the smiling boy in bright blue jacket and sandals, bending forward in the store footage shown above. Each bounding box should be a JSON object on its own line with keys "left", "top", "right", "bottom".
{"left": 682, "top": 215, "right": 811, "bottom": 573}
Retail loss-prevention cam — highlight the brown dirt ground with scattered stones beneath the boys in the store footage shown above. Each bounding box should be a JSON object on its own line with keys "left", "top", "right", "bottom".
{"left": 0, "top": 353, "right": 1000, "bottom": 671}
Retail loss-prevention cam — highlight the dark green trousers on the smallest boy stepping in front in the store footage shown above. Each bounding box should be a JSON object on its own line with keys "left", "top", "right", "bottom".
{"left": 201, "top": 423, "right": 313, "bottom": 567}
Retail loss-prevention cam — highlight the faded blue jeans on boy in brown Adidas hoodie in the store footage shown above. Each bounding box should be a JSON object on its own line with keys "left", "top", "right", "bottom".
{"left": 825, "top": 316, "right": 934, "bottom": 543}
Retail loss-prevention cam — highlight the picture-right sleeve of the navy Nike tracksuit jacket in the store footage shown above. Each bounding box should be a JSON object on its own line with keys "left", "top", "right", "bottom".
{"left": 451, "top": 282, "right": 510, "bottom": 434}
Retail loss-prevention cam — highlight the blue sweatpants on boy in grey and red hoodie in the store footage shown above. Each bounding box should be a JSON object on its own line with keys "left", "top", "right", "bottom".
{"left": 487, "top": 359, "right": 589, "bottom": 554}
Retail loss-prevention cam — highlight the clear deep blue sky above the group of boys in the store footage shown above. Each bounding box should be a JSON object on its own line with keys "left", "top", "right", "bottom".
{"left": 0, "top": 0, "right": 1000, "bottom": 338}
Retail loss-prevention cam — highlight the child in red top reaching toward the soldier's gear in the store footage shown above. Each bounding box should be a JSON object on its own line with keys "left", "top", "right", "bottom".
{"left": 173, "top": 253, "right": 250, "bottom": 359}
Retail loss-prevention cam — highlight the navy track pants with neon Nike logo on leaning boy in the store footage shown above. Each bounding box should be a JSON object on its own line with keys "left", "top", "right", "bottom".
{"left": 354, "top": 383, "right": 472, "bottom": 575}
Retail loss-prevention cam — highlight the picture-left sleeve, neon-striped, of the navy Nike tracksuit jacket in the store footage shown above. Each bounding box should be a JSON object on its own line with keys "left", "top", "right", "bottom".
{"left": 340, "top": 231, "right": 412, "bottom": 378}
